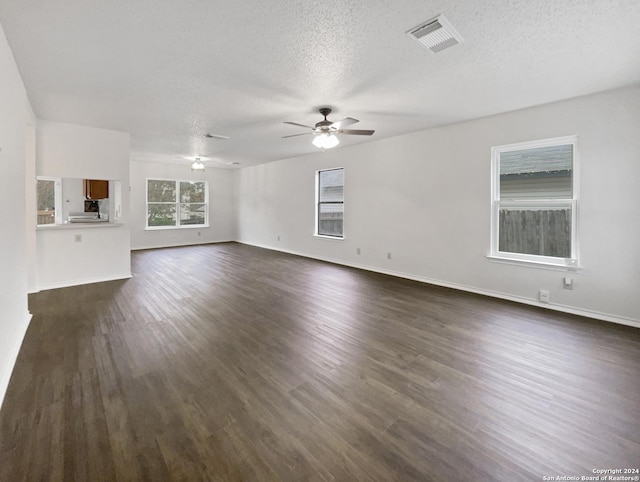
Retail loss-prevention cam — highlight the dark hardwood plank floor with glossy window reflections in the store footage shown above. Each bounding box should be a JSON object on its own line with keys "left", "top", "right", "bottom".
{"left": 0, "top": 243, "right": 640, "bottom": 482}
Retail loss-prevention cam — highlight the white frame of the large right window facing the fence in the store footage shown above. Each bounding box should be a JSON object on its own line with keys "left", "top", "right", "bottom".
{"left": 487, "top": 136, "right": 579, "bottom": 269}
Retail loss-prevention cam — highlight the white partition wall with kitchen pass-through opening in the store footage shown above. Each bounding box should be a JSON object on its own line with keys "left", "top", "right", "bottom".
{"left": 36, "top": 120, "right": 131, "bottom": 289}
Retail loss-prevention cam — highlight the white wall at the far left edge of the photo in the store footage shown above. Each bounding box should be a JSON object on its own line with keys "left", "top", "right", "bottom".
{"left": 0, "top": 21, "right": 31, "bottom": 405}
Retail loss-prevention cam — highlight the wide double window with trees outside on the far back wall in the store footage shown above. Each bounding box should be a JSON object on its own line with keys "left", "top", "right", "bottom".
{"left": 147, "top": 179, "right": 209, "bottom": 229}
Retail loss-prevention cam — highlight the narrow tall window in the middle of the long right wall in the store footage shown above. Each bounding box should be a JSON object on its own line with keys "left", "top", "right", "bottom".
{"left": 316, "top": 168, "right": 344, "bottom": 238}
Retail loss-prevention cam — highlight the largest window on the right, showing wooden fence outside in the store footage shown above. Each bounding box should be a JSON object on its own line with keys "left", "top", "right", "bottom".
{"left": 491, "top": 137, "right": 577, "bottom": 266}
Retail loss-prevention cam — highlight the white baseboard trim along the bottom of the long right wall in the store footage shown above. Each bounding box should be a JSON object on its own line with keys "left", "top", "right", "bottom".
{"left": 236, "top": 241, "right": 640, "bottom": 328}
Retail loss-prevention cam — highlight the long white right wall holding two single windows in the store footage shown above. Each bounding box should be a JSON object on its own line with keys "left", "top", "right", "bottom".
{"left": 238, "top": 87, "right": 640, "bottom": 326}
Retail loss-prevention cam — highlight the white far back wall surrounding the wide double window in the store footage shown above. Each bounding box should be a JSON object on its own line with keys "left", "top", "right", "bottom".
{"left": 130, "top": 161, "right": 237, "bottom": 249}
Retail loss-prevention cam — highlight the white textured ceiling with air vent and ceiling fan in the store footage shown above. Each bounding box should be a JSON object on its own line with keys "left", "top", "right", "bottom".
{"left": 0, "top": 0, "right": 640, "bottom": 167}
